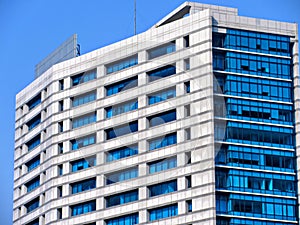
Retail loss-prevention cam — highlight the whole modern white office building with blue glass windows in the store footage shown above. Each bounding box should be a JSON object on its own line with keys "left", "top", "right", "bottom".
{"left": 13, "top": 2, "right": 300, "bottom": 225}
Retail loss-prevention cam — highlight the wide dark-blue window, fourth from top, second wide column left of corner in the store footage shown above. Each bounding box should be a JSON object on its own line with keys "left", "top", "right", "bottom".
{"left": 105, "top": 121, "right": 138, "bottom": 140}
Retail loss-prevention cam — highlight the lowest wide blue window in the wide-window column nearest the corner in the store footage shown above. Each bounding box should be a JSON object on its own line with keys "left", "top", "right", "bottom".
{"left": 149, "top": 204, "right": 178, "bottom": 221}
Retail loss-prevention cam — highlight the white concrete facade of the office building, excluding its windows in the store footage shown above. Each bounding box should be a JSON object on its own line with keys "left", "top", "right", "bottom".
{"left": 13, "top": 2, "right": 299, "bottom": 225}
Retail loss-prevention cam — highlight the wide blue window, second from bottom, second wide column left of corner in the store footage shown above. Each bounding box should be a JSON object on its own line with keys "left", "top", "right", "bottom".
{"left": 105, "top": 190, "right": 139, "bottom": 208}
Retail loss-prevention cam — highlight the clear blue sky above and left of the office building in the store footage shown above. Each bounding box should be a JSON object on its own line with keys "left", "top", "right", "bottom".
{"left": 0, "top": 0, "right": 300, "bottom": 225}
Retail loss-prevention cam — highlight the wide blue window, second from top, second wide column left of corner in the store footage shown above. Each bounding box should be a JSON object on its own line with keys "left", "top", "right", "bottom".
{"left": 105, "top": 76, "right": 138, "bottom": 96}
